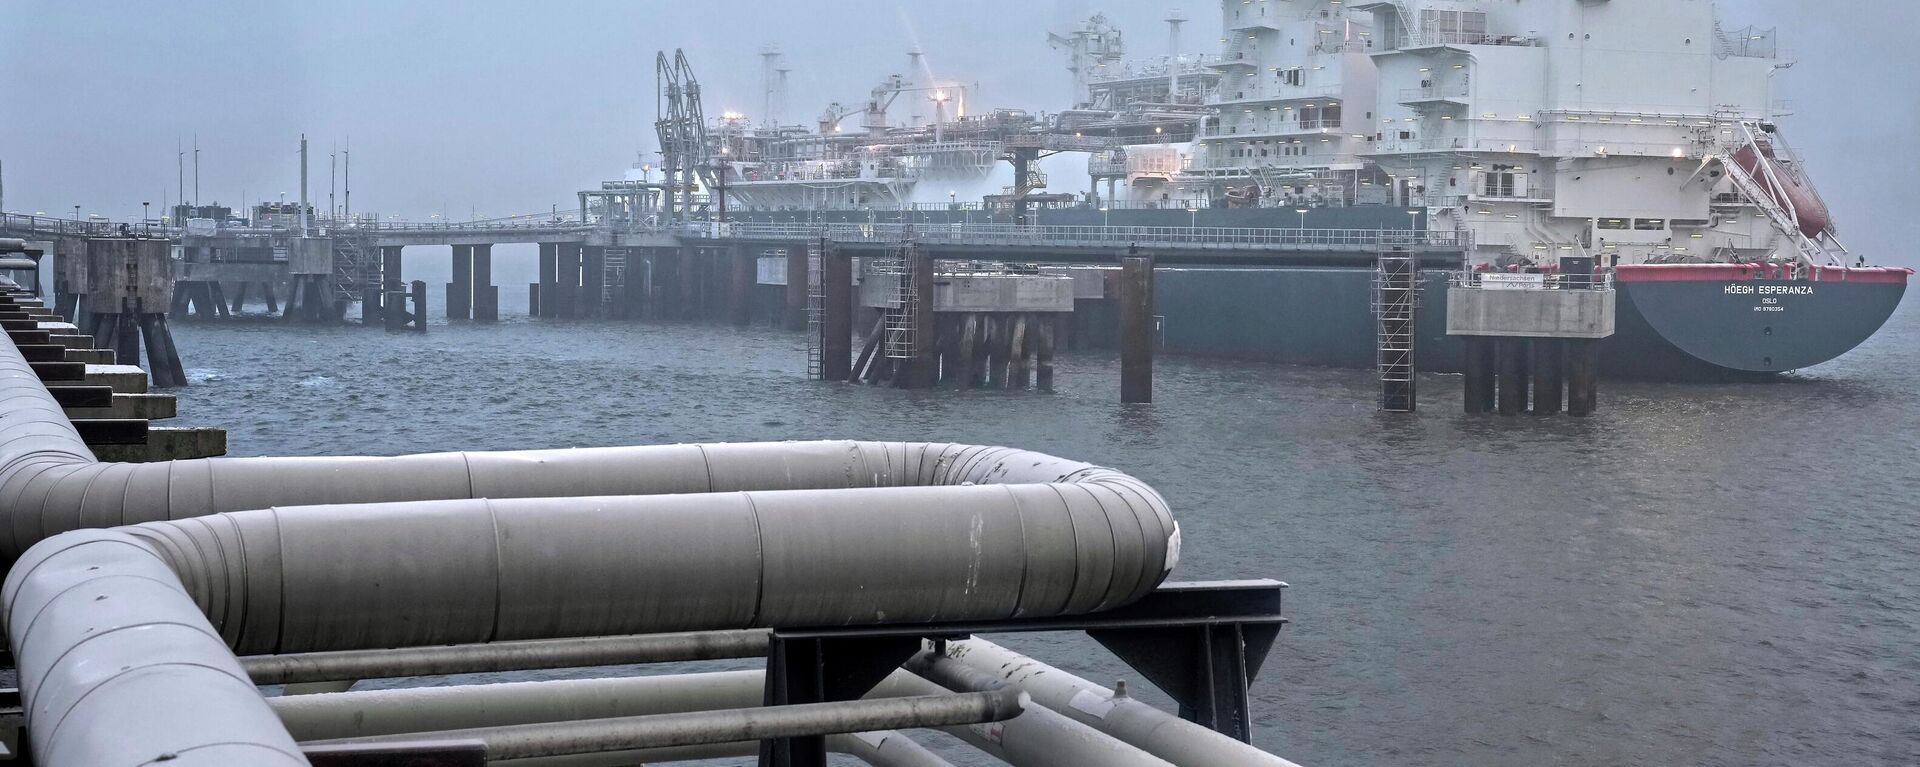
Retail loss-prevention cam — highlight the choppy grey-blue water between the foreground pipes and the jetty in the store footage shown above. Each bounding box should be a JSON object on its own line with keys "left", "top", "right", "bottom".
{"left": 177, "top": 302, "right": 1920, "bottom": 765}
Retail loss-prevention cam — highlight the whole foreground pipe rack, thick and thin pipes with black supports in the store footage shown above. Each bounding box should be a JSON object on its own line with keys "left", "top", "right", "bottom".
{"left": 0, "top": 282, "right": 1290, "bottom": 767}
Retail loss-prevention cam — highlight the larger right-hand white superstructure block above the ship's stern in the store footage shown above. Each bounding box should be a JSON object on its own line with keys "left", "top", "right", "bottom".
{"left": 1359, "top": 0, "right": 1824, "bottom": 263}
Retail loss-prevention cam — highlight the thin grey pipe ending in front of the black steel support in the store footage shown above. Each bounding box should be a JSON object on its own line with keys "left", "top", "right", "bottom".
{"left": 295, "top": 688, "right": 1027, "bottom": 761}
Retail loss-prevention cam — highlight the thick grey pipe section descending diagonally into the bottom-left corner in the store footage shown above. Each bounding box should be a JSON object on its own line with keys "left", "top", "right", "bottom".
{"left": 0, "top": 530, "right": 307, "bottom": 767}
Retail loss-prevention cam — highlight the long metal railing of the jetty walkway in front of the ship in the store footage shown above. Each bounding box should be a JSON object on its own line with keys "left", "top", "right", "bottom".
{"left": 678, "top": 223, "right": 1473, "bottom": 252}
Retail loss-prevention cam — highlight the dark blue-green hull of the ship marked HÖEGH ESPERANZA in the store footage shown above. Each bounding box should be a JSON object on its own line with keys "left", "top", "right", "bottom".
{"left": 1154, "top": 267, "right": 1907, "bottom": 381}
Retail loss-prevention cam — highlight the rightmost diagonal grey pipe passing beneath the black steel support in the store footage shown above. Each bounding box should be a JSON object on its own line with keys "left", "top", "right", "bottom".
{"left": 947, "top": 638, "right": 1300, "bottom": 767}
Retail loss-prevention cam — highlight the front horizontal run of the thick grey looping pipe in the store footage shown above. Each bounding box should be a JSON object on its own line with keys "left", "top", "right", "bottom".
{"left": 86, "top": 484, "right": 1164, "bottom": 654}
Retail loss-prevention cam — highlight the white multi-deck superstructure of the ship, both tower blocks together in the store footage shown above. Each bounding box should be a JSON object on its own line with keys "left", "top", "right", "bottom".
{"left": 1136, "top": 0, "right": 1845, "bottom": 271}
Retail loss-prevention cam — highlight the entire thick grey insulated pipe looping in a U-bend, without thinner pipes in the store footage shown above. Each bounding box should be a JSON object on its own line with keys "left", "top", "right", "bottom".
{"left": 0, "top": 326, "right": 1179, "bottom": 767}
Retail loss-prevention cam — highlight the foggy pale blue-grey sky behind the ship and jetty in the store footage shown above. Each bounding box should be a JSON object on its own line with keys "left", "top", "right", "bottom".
{"left": 0, "top": 0, "right": 1920, "bottom": 265}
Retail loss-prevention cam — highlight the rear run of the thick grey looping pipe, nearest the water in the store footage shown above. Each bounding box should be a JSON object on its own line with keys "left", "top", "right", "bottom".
{"left": 0, "top": 438, "right": 1179, "bottom": 561}
